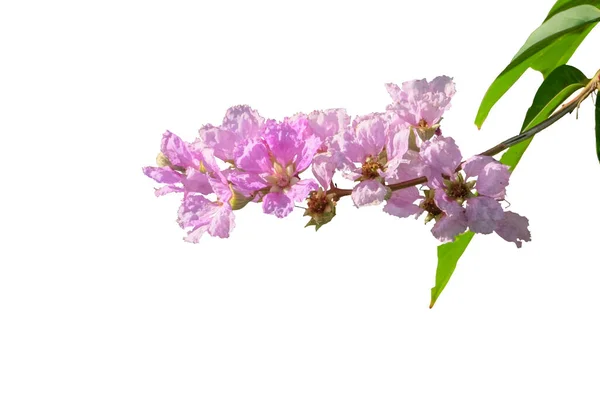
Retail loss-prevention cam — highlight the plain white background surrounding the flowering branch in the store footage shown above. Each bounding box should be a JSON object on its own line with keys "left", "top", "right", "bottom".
{"left": 0, "top": 0, "right": 600, "bottom": 400}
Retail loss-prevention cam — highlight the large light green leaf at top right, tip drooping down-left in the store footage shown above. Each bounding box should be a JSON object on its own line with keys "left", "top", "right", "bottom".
{"left": 475, "top": 4, "right": 600, "bottom": 128}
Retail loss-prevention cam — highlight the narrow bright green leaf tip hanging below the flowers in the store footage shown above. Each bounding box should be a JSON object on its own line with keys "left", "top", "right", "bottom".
{"left": 429, "top": 231, "right": 475, "bottom": 308}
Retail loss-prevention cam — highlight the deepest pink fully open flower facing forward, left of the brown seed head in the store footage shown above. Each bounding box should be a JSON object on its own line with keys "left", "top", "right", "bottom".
{"left": 229, "top": 118, "right": 321, "bottom": 218}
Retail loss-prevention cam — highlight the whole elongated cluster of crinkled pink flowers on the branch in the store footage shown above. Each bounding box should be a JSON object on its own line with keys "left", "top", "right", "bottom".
{"left": 143, "top": 76, "right": 531, "bottom": 247}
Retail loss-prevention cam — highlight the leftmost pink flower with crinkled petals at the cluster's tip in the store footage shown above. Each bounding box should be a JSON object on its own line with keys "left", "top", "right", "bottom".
{"left": 142, "top": 131, "right": 212, "bottom": 196}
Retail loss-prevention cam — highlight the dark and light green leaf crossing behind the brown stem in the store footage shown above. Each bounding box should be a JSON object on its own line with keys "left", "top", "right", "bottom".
{"left": 500, "top": 65, "right": 589, "bottom": 170}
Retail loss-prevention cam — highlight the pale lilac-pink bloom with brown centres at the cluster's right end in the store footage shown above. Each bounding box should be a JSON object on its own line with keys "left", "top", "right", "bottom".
{"left": 384, "top": 137, "right": 531, "bottom": 247}
